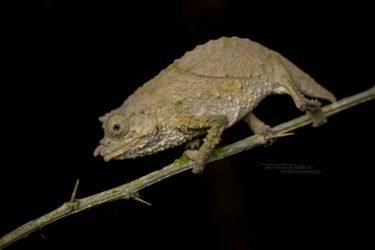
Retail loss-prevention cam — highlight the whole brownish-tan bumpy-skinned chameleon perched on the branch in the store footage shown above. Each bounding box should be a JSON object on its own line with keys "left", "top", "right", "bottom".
{"left": 94, "top": 37, "right": 336, "bottom": 173}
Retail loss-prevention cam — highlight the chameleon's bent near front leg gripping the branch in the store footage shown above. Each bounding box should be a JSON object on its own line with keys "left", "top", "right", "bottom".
{"left": 176, "top": 115, "right": 228, "bottom": 174}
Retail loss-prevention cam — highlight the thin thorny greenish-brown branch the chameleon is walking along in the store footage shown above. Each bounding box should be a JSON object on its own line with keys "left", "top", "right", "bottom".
{"left": 0, "top": 86, "right": 375, "bottom": 249}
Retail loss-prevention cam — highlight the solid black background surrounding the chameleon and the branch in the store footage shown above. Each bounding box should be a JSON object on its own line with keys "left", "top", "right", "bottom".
{"left": 0, "top": 0, "right": 375, "bottom": 249}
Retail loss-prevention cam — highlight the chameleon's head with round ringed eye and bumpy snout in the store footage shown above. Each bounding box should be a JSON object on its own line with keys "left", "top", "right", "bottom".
{"left": 94, "top": 109, "right": 159, "bottom": 161}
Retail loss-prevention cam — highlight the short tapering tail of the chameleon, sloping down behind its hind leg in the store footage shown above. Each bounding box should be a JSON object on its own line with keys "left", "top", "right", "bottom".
{"left": 279, "top": 56, "right": 336, "bottom": 102}
